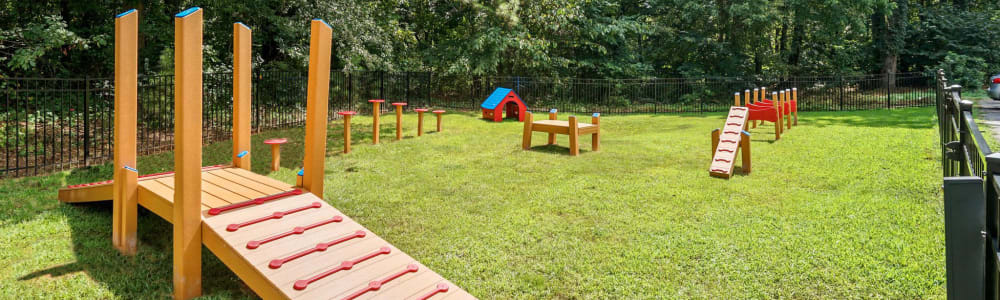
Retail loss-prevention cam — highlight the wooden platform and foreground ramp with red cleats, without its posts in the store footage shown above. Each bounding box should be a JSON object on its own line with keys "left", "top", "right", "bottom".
{"left": 60, "top": 168, "right": 475, "bottom": 299}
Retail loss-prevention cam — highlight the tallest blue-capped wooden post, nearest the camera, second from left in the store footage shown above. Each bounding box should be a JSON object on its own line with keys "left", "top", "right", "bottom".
{"left": 173, "top": 7, "right": 202, "bottom": 299}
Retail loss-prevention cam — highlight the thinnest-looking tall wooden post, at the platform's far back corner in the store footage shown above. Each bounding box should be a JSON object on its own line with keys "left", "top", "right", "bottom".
{"left": 233, "top": 22, "right": 252, "bottom": 170}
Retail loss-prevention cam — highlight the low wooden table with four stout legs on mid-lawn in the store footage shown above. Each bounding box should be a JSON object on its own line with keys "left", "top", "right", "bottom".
{"left": 521, "top": 112, "right": 601, "bottom": 156}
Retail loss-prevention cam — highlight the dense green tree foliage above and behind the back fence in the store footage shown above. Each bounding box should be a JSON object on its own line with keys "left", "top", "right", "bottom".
{"left": 0, "top": 0, "right": 1000, "bottom": 78}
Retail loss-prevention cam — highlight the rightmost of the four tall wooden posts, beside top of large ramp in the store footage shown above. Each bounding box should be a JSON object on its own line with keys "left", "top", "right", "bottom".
{"left": 302, "top": 19, "right": 333, "bottom": 199}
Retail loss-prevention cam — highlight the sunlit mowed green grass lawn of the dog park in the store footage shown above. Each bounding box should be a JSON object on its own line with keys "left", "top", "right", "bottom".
{"left": 0, "top": 108, "right": 945, "bottom": 299}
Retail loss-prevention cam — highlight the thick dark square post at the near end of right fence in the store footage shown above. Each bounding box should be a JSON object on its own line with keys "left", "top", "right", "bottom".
{"left": 944, "top": 176, "right": 993, "bottom": 299}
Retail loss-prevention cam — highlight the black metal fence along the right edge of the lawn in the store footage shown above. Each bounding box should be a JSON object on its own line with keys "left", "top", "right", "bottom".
{"left": 935, "top": 71, "right": 1000, "bottom": 300}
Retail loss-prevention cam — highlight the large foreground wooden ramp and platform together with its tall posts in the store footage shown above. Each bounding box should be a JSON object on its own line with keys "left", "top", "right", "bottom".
{"left": 60, "top": 8, "right": 473, "bottom": 299}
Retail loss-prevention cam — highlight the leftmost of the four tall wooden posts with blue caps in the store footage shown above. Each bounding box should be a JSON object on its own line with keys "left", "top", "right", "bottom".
{"left": 111, "top": 9, "right": 139, "bottom": 255}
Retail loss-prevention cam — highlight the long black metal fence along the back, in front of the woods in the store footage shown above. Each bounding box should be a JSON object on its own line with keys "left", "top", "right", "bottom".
{"left": 0, "top": 71, "right": 934, "bottom": 177}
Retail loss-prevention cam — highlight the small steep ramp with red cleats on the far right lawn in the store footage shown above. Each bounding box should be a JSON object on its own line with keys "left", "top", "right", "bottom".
{"left": 708, "top": 106, "right": 750, "bottom": 179}
